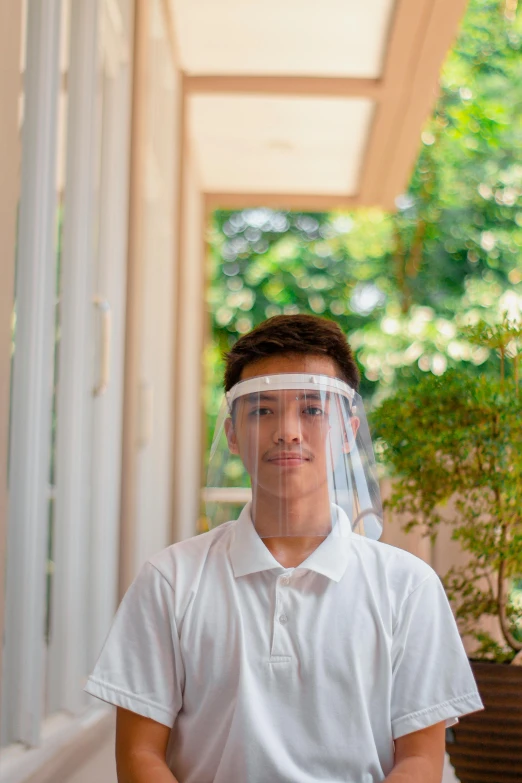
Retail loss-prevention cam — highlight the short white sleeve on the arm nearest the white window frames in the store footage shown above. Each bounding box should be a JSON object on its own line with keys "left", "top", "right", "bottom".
{"left": 85, "top": 563, "right": 183, "bottom": 727}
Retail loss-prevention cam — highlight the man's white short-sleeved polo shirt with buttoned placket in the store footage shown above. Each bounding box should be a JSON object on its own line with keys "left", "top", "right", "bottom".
{"left": 86, "top": 506, "right": 482, "bottom": 783}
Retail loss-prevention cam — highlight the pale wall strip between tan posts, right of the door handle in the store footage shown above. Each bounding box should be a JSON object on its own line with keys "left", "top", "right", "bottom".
{"left": 134, "top": 0, "right": 181, "bottom": 571}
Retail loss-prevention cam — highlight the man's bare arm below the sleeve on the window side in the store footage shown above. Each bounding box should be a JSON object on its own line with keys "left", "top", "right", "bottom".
{"left": 116, "top": 707, "right": 178, "bottom": 783}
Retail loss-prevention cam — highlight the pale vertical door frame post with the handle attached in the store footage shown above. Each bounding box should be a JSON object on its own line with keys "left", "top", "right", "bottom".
{"left": 87, "top": 0, "right": 134, "bottom": 670}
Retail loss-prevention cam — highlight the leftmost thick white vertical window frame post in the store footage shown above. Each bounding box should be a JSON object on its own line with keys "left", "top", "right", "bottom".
{"left": 1, "top": 0, "right": 61, "bottom": 745}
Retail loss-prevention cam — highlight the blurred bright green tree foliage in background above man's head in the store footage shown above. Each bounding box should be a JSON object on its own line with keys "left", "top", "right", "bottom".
{"left": 209, "top": 0, "right": 522, "bottom": 398}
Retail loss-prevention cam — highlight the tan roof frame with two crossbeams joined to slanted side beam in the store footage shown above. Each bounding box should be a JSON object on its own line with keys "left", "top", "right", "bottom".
{"left": 183, "top": 0, "right": 467, "bottom": 211}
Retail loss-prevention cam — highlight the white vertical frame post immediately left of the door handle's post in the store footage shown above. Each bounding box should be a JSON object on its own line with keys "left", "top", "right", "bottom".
{"left": 46, "top": 0, "right": 98, "bottom": 715}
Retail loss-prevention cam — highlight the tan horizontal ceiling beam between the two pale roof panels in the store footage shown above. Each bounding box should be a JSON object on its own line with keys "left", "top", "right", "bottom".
{"left": 185, "top": 74, "right": 383, "bottom": 101}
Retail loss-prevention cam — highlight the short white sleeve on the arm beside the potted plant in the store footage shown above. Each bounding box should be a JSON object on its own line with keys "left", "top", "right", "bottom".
{"left": 391, "top": 572, "right": 483, "bottom": 739}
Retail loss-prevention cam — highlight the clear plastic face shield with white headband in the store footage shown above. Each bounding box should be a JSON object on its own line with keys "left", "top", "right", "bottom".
{"left": 205, "top": 373, "right": 382, "bottom": 539}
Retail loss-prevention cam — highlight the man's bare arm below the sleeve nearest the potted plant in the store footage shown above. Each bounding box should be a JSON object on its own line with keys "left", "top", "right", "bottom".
{"left": 384, "top": 721, "right": 445, "bottom": 783}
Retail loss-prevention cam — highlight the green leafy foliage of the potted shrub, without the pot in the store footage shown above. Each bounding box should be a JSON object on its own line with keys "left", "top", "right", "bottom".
{"left": 372, "top": 321, "right": 522, "bottom": 661}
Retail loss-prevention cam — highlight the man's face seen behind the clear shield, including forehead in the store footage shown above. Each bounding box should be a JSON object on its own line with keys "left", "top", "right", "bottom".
{"left": 226, "top": 355, "right": 354, "bottom": 500}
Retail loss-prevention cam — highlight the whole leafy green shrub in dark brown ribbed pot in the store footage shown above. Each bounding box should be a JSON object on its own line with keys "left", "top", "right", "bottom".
{"left": 373, "top": 319, "right": 522, "bottom": 783}
